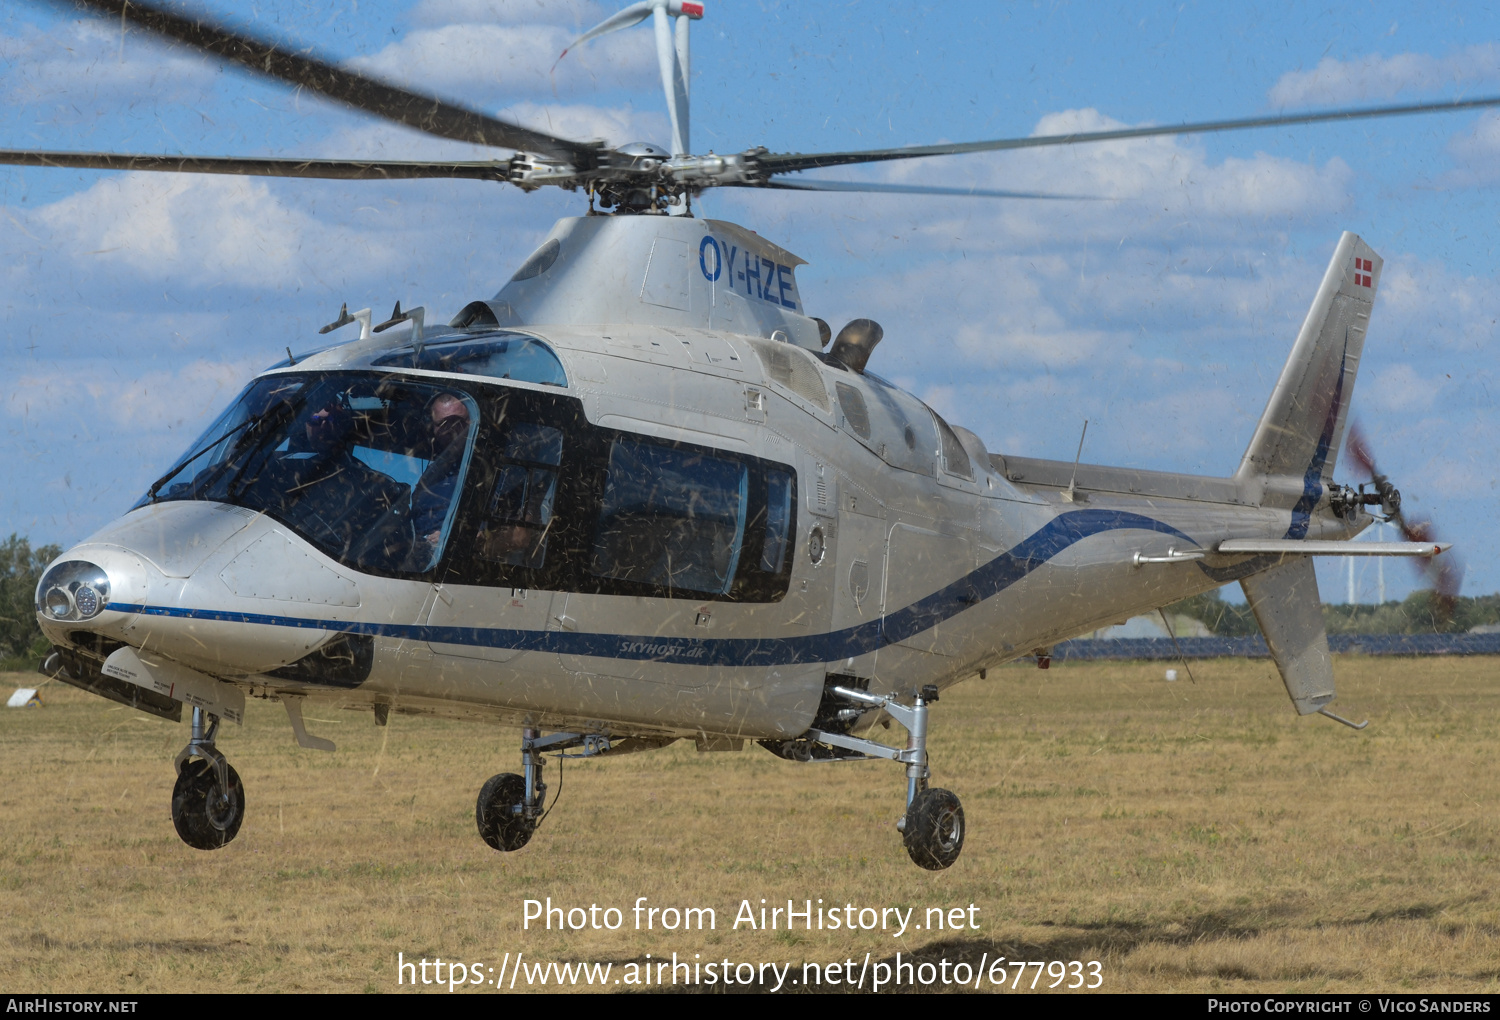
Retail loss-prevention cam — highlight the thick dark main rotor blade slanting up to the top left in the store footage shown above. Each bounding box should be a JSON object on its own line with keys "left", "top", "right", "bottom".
{"left": 63, "top": 0, "right": 596, "bottom": 161}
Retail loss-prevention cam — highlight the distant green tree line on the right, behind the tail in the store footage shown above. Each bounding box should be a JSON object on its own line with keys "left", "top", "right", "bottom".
{"left": 1167, "top": 591, "right": 1500, "bottom": 638}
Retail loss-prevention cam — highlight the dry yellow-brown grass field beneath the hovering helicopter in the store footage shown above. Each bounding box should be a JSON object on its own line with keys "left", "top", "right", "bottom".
{"left": 0, "top": 659, "right": 1500, "bottom": 995}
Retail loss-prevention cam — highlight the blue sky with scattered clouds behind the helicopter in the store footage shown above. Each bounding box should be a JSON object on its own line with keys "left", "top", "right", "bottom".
{"left": 0, "top": 0, "right": 1500, "bottom": 600}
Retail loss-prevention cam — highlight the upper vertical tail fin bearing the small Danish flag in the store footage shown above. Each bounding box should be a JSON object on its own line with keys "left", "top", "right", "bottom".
{"left": 1235, "top": 233, "right": 1382, "bottom": 525}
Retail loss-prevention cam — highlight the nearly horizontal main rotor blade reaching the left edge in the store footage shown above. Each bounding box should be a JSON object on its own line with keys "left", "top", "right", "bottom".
{"left": 0, "top": 149, "right": 510, "bottom": 182}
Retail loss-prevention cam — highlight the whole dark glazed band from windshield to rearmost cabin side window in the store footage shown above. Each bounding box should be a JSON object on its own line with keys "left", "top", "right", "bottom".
{"left": 144, "top": 372, "right": 797, "bottom": 602}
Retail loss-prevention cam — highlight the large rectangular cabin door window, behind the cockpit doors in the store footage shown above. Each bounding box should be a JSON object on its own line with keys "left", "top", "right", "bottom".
{"left": 590, "top": 438, "right": 750, "bottom": 596}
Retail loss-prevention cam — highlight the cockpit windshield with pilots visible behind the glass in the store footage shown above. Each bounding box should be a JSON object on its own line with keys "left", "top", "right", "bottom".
{"left": 141, "top": 374, "right": 479, "bottom": 573}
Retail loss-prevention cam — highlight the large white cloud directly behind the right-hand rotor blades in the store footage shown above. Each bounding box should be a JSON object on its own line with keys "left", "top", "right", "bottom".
{"left": 741, "top": 110, "right": 1353, "bottom": 270}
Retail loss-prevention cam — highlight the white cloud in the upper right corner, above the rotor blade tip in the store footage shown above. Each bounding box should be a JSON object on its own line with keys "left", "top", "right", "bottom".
{"left": 1269, "top": 42, "right": 1500, "bottom": 107}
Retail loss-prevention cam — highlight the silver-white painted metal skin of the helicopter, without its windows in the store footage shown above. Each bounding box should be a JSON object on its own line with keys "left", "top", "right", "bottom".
{"left": 39, "top": 216, "right": 1404, "bottom": 750}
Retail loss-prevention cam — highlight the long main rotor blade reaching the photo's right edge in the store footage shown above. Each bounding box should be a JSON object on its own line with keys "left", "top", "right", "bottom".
{"left": 756, "top": 96, "right": 1500, "bottom": 174}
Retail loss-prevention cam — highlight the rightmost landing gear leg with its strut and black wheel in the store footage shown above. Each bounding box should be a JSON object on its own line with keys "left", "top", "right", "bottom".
{"left": 765, "top": 684, "right": 965, "bottom": 872}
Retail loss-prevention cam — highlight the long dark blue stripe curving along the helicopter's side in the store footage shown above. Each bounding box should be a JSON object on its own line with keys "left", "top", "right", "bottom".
{"left": 108, "top": 510, "right": 1193, "bottom": 666}
